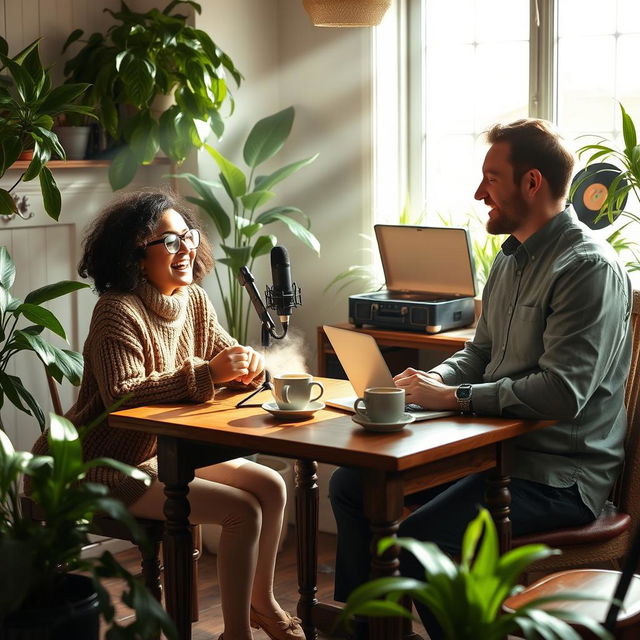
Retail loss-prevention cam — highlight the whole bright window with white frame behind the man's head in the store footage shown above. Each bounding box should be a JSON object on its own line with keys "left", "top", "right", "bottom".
{"left": 374, "top": 0, "right": 640, "bottom": 235}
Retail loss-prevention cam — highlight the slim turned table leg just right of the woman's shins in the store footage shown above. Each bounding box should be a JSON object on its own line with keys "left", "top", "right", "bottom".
{"left": 295, "top": 460, "right": 318, "bottom": 640}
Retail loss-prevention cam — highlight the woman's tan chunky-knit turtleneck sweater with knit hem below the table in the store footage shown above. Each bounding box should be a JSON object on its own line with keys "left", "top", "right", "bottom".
{"left": 33, "top": 283, "right": 253, "bottom": 504}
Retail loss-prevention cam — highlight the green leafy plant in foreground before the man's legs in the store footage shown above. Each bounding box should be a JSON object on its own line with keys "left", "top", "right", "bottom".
{"left": 338, "top": 509, "right": 612, "bottom": 640}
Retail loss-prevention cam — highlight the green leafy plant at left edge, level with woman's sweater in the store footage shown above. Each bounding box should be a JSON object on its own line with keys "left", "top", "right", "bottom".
{"left": 0, "top": 247, "right": 89, "bottom": 431}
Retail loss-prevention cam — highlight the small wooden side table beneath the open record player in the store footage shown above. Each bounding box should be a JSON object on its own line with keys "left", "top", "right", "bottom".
{"left": 317, "top": 322, "right": 475, "bottom": 376}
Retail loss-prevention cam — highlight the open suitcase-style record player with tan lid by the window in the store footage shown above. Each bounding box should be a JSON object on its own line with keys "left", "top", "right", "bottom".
{"left": 349, "top": 224, "right": 476, "bottom": 333}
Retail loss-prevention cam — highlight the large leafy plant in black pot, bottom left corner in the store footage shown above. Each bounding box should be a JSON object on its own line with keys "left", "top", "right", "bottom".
{"left": 0, "top": 414, "right": 176, "bottom": 640}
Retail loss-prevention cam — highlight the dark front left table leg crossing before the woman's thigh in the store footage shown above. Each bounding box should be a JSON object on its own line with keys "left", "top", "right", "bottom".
{"left": 158, "top": 436, "right": 194, "bottom": 640}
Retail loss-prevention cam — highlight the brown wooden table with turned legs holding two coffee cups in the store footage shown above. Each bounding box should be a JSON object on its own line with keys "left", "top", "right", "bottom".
{"left": 109, "top": 379, "right": 551, "bottom": 640}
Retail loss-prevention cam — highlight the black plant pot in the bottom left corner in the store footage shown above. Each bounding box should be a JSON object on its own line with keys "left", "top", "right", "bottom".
{"left": 0, "top": 574, "right": 100, "bottom": 640}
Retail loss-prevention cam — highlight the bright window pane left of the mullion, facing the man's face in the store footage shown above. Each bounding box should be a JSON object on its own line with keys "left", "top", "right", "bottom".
{"left": 423, "top": 0, "right": 529, "bottom": 225}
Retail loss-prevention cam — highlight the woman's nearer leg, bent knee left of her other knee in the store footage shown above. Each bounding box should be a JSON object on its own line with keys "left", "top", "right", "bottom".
{"left": 130, "top": 463, "right": 262, "bottom": 640}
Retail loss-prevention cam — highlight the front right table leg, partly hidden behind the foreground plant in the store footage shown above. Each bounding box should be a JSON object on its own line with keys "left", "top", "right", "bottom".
{"left": 363, "top": 471, "right": 404, "bottom": 640}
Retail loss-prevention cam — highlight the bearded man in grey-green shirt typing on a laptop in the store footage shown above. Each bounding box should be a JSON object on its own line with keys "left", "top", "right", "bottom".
{"left": 330, "top": 119, "right": 632, "bottom": 638}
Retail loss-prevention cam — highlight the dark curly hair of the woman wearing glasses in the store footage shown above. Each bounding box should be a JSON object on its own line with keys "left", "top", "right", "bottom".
{"left": 78, "top": 191, "right": 213, "bottom": 294}
